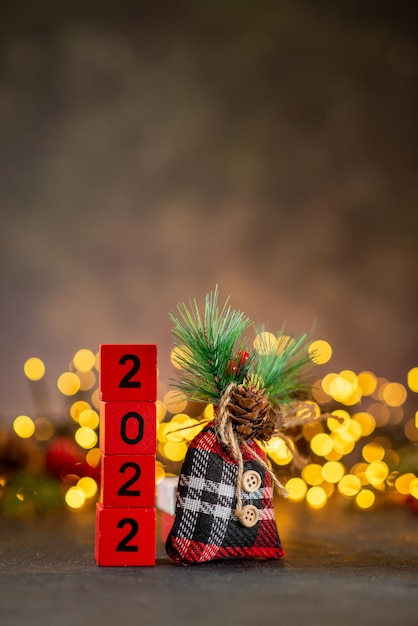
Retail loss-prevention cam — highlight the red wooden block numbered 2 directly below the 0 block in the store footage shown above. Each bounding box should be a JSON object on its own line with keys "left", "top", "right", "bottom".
{"left": 101, "top": 454, "right": 155, "bottom": 507}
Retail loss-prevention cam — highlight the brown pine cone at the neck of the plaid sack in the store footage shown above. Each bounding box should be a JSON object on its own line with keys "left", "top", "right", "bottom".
{"left": 228, "top": 383, "right": 278, "bottom": 441}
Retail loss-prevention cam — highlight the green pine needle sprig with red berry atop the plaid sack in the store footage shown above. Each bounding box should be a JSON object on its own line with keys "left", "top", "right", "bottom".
{"left": 169, "top": 286, "right": 311, "bottom": 405}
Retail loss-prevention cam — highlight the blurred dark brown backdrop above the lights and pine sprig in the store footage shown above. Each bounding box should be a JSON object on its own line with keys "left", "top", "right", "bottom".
{"left": 0, "top": 0, "right": 418, "bottom": 417}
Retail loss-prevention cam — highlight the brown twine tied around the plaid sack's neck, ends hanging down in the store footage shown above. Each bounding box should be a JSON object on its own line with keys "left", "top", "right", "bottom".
{"left": 216, "top": 382, "right": 288, "bottom": 520}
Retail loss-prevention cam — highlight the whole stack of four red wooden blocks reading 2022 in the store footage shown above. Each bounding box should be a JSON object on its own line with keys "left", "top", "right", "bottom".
{"left": 95, "top": 344, "right": 157, "bottom": 566}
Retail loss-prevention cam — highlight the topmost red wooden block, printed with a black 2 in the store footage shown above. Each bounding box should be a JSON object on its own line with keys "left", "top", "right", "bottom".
{"left": 99, "top": 343, "right": 157, "bottom": 402}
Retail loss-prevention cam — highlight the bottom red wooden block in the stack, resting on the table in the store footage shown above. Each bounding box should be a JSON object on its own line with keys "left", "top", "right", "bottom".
{"left": 94, "top": 503, "right": 156, "bottom": 567}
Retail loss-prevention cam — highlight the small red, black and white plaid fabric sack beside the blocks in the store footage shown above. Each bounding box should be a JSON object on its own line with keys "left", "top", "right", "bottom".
{"left": 166, "top": 423, "right": 283, "bottom": 564}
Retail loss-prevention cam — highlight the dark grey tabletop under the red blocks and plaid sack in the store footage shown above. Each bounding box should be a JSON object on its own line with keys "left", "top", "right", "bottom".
{"left": 0, "top": 501, "right": 418, "bottom": 626}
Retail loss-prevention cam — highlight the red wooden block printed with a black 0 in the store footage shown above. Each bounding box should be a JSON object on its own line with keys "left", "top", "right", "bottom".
{"left": 100, "top": 401, "right": 157, "bottom": 454}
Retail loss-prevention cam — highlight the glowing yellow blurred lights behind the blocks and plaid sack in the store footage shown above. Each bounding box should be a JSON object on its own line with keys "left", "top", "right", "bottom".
{"left": 5, "top": 332, "right": 418, "bottom": 511}
